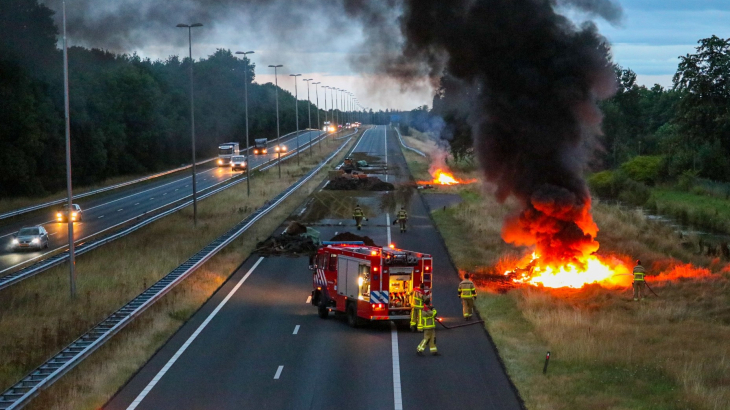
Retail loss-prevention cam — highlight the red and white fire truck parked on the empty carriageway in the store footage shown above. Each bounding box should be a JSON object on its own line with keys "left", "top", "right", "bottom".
{"left": 311, "top": 242, "right": 433, "bottom": 327}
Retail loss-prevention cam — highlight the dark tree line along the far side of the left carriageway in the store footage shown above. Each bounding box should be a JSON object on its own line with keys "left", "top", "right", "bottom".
{"left": 0, "top": 0, "right": 364, "bottom": 197}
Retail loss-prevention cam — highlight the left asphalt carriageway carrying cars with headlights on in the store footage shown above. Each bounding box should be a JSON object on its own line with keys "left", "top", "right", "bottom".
{"left": 0, "top": 131, "right": 319, "bottom": 276}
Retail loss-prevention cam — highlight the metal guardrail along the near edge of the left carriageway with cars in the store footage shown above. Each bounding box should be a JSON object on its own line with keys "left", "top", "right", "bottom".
{"left": 0, "top": 128, "right": 336, "bottom": 292}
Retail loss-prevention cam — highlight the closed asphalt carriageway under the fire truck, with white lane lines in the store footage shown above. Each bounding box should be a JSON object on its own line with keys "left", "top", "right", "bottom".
{"left": 104, "top": 126, "right": 521, "bottom": 410}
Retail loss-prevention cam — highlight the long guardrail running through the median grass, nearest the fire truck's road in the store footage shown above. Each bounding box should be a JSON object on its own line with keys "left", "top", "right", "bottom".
{"left": 0, "top": 128, "right": 356, "bottom": 410}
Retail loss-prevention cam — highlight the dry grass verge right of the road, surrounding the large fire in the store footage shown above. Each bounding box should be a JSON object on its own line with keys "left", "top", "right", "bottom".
{"left": 409, "top": 147, "right": 730, "bottom": 410}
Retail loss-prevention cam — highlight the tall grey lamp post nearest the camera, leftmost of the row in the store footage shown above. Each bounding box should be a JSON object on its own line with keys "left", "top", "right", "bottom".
{"left": 62, "top": 1, "right": 76, "bottom": 298}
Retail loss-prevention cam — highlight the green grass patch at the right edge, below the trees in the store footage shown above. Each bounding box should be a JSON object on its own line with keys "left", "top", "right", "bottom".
{"left": 649, "top": 188, "right": 730, "bottom": 233}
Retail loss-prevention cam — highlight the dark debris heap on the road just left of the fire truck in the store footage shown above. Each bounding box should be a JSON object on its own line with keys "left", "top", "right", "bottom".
{"left": 256, "top": 221, "right": 320, "bottom": 256}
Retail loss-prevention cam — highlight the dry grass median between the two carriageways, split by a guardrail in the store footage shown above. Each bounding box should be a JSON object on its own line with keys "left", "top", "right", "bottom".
{"left": 0, "top": 132, "right": 362, "bottom": 409}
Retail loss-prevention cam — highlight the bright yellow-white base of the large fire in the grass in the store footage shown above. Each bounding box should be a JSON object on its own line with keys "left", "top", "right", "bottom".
{"left": 505, "top": 253, "right": 633, "bottom": 289}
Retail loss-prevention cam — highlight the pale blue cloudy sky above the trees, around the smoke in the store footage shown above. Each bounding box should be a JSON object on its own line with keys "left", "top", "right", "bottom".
{"left": 57, "top": 0, "right": 730, "bottom": 110}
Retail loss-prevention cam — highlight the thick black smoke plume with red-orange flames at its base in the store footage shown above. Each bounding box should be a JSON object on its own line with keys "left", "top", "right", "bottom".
{"left": 385, "top": 0, "right": 621, "bottom": 263}
